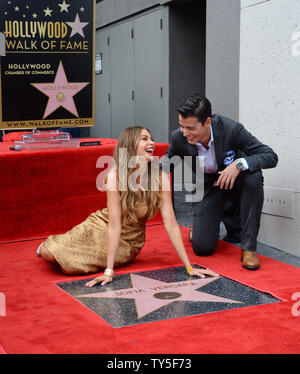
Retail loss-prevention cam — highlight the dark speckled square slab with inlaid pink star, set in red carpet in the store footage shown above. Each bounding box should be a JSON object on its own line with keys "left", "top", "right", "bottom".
{"left": 57, "top": 266, "right": 280, "bottom": 328}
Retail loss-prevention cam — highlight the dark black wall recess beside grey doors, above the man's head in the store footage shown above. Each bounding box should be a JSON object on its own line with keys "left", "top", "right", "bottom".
{"left": 169, "top": 0, "right": 206, "bottom": 133}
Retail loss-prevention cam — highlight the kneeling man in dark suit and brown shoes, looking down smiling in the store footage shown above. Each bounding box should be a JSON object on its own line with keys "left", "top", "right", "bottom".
{"left": 163, "top": 94, "right": 278, "bottom": 270}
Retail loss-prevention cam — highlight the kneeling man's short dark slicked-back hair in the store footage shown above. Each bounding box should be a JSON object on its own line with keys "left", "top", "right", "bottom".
{"left": 177, "top": 93, "right": 212, "bottom": 125}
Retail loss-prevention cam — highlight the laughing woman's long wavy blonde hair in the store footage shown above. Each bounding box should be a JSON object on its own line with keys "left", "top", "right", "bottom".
{"left": 114, "top": 126, "right": 161, "bottom": 223}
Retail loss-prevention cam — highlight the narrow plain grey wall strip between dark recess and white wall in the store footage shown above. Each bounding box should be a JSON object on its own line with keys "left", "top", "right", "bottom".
{"left": 205, "top": 0, "right": 240, "bottom": 120}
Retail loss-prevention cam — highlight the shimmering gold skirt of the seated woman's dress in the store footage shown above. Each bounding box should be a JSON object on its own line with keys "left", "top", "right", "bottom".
{"left": 43, "top": 201, "right": 152, "bottom": 274}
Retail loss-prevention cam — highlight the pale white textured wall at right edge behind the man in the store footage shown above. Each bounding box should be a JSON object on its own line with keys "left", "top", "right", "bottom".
{"left": 239, "top": 0, "right": 300, "bottom": 256}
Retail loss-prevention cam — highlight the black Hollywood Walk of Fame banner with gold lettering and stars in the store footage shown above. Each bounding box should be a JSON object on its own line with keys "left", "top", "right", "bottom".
{"left": 0, "top": 0, "right": 96, "bottom": 130}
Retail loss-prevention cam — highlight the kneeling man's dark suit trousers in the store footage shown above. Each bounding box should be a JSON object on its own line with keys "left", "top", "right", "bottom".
{"left": 192, "top": 170, "right": 264, "bottom": 256}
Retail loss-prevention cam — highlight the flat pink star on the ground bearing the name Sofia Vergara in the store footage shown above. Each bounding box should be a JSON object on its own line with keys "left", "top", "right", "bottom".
{"left": 76, "top": 274, "right": 243, "bottom": 319}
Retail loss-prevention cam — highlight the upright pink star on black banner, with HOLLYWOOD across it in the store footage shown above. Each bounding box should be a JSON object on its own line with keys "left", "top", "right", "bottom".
{"left": 31, "top": 61, "right": 89, "bottom": 119}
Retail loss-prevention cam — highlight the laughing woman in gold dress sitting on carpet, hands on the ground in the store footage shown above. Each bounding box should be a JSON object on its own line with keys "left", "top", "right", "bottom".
{"left": 37, "top": 126, "right": 218, "bottom": 287}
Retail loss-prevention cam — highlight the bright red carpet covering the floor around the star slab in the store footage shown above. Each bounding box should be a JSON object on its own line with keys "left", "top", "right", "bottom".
{"left": 0, "top": 225, "right": 300, "bottom": 354}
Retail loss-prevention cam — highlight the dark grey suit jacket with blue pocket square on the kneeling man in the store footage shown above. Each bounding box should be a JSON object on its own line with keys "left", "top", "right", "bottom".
{"left": 162, "top": 114, "right": 278, "bottom": 188}
